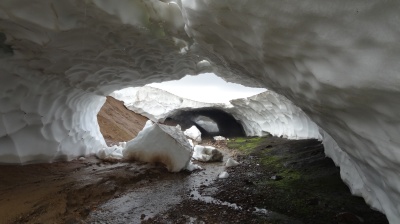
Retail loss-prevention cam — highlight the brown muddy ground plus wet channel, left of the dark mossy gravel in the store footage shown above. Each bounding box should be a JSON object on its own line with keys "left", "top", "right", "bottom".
{"left": 0, "top": 146, "right": 231, "bottom": 223}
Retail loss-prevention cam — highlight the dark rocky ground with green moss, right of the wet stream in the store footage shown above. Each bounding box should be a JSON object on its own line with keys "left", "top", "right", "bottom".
{"left": 143, "top": 137, "right": 388, "bottom": 224}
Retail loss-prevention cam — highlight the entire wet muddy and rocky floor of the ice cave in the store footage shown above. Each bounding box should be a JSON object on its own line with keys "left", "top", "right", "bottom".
{"left": 0, "top": 137, "right": 387, "bottom": 224}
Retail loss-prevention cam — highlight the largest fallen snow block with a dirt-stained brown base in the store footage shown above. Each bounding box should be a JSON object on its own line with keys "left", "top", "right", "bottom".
{"left": 123, "top": 124, "right": 193, "bottom": 172}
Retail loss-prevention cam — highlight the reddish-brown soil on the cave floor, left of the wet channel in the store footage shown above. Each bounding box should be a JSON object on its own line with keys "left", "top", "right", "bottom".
{"left": 0, "top": 158, "right": 186, "bottom": 224}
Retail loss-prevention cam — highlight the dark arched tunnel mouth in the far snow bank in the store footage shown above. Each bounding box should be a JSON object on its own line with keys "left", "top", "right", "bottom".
{"left": 164, "top": 107, "right": 246, "bottom": 138}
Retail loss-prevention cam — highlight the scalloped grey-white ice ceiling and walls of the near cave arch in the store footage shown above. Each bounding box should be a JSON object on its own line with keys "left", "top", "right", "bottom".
{"left": 0, "top": 0, "right": 400, "bottom": 223}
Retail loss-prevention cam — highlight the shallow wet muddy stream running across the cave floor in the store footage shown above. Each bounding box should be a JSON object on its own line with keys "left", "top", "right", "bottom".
{"left": 87, "top": 155, "right": 230, "bottom": 223}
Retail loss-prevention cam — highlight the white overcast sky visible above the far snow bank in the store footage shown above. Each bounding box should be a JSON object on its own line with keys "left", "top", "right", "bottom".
{"left": 148, "top": 73, "right": 266, "bottom": 103}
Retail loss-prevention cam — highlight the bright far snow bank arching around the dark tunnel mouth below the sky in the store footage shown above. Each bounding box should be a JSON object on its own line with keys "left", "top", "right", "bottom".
{"left": 111, "top": 86, "right": 321, "bottom": 139}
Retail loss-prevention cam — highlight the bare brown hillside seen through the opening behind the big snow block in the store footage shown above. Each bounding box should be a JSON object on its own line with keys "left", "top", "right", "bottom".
{"left": 97, "top": 96, "right": 148, "bottom": 145}
